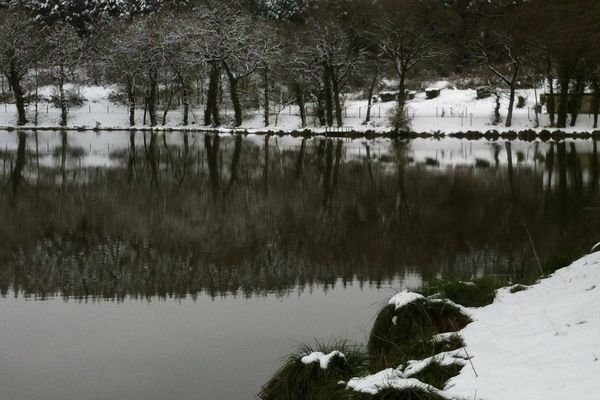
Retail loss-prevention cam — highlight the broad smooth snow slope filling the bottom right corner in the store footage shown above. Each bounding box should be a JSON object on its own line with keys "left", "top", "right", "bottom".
{"left": 445, "top": 253, "right": 600, "bottom": 400}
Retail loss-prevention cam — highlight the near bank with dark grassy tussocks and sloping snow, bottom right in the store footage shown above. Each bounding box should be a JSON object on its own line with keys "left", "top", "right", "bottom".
{"left": 262, "top": 253, "right": 600, "bottom": 400}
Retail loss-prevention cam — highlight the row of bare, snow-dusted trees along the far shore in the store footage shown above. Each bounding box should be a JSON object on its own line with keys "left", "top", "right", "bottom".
{"left": 0, "top": 0, "right": 600, "bottom": 128}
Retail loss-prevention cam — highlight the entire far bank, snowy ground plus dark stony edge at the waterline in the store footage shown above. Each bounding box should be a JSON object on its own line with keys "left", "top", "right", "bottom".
{"left": 0, "top": 86, "right": 600, "bottom": 140}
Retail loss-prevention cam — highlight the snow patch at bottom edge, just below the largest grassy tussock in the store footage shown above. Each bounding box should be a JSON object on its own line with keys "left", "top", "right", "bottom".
{"left": 346, "top": 368, "right": 444, "bottom": 397}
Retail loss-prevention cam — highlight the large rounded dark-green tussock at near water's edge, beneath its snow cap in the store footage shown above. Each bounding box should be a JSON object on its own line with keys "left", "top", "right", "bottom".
{"left": 367, "top": 299, "right": 471, "bottom": 369}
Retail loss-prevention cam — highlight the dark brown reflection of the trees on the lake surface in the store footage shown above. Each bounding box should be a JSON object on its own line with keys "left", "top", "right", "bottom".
{"left": 0, "top": 133, "right": 600, "bottom": 298}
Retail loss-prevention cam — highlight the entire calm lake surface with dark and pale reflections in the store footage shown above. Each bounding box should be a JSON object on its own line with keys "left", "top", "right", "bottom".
{"left": 0, "top": 131, "right": 600, "bottom": 399}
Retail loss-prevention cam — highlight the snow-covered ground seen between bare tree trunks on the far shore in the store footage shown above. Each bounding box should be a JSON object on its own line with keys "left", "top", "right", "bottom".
{"left": 0, "top": 86, "right": 593, "bottom": 133}
